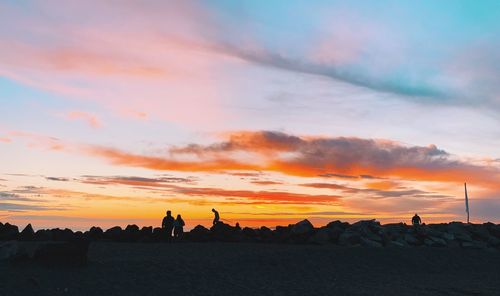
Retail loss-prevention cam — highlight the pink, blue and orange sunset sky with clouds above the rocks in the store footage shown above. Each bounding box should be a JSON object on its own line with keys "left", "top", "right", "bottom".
{"left": 0, "top": 0, "right": 500, "bottom": 230}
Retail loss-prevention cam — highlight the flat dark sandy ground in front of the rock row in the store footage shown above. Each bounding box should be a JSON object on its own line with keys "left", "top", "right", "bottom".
{"left": 0, "top": 242, "right": 500, "bottom": 296}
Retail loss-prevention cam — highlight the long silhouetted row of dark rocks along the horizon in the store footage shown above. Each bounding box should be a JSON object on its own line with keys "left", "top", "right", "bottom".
{"left": 0, "top": 220, "right": 500, "bottom": 249}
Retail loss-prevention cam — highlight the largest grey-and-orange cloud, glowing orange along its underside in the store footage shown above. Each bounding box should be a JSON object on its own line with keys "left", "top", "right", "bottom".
{"left": 80, "top": 131, "right": 500, "bottom": 187}
